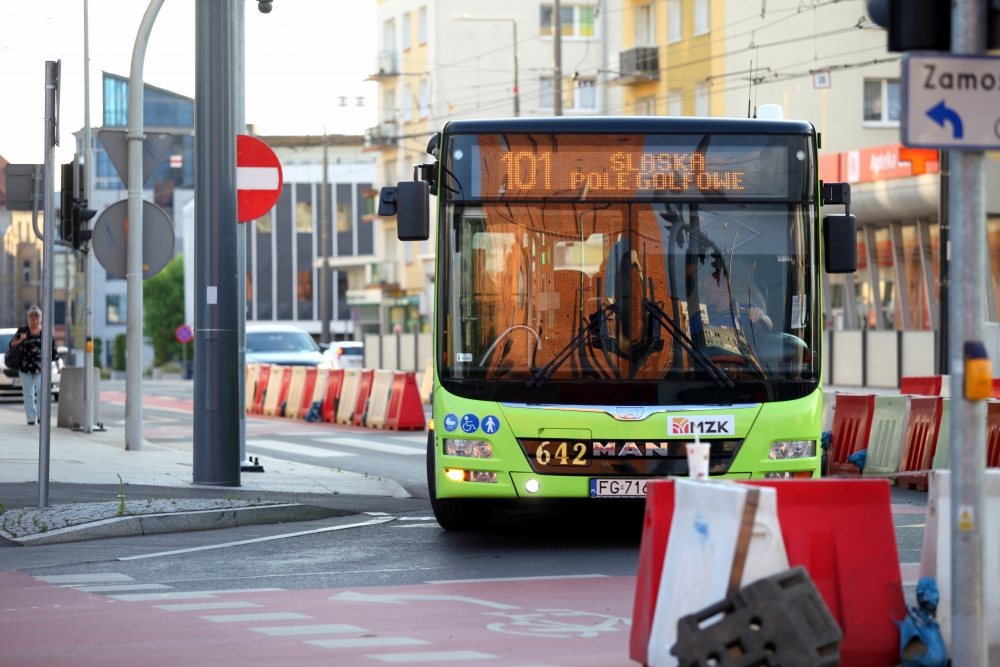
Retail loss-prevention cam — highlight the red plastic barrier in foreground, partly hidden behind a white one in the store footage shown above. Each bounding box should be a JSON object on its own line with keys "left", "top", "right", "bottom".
{"left": 629, "top": 479, "right": 906, "bottom": 667}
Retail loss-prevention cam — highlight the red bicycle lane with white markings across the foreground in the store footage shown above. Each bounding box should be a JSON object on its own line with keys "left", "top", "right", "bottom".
{"left": 0, "top": 572, "right": 635, "bottom": 667}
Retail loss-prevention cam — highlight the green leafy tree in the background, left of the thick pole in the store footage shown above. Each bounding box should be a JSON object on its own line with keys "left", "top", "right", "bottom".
{"left": 142, "top": 255, "right": 184, "bottom": 366}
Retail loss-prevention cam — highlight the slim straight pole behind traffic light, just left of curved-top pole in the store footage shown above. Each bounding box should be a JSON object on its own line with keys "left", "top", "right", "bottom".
{"left": 82, "top": 0, "right": 95, "bottom": 433}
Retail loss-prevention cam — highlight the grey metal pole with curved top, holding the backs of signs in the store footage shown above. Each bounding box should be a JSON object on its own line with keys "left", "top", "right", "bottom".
{"left": 125, "top": 0, "right": 163, "bottom": 451}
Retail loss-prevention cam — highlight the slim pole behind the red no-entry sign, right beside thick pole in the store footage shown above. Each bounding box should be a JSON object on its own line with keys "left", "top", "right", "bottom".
{"left": 233, "top": 0, "right": 251, "bottom": 466}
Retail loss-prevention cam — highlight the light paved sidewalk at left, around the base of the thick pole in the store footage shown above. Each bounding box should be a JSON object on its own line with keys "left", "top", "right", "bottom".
{"left": 0, "top": 409, "right": 409, "bottom": 498}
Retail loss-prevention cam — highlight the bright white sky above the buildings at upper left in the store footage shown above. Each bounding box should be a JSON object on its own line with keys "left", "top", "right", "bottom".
{"left": 0, "top": 0, "right": 377, "bottom": 163}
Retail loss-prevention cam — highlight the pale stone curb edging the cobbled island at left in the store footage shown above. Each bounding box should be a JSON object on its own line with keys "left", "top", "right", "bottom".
{"left": 5, "top": 503, "right": 353, "bottom": 547}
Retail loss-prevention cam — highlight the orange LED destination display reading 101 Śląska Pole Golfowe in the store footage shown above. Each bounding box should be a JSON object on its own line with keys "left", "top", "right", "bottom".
{"left": 458, "top": 135, "right": 808, "bottom": 201}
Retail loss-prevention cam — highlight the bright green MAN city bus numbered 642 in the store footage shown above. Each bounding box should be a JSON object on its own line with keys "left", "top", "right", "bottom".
{"left": 380, "top": 117, "right": 856, "bottom": 530}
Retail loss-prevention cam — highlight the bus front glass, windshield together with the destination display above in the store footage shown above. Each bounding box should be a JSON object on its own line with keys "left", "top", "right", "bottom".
{"left": 438, "top": 135, "right": 819, "bottom": 402}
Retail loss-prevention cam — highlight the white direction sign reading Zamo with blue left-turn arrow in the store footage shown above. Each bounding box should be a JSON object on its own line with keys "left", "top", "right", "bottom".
{"left": 901, "top": 53, "right": 1000, "bottom": 151}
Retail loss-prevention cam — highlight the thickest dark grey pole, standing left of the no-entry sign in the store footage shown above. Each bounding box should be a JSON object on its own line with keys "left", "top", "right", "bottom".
{"left": 193, "top": 0, "right": 245, "bottom": 486}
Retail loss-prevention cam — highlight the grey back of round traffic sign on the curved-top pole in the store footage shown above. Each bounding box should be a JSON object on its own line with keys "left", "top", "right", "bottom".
{"left": 90, "top": 199, "right": 174, "bottom": 280}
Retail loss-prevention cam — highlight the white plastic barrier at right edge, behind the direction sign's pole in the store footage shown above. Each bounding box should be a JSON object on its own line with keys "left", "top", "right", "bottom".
{"left": 920, "top": 470, "right": 1000, "bottom": 665}
